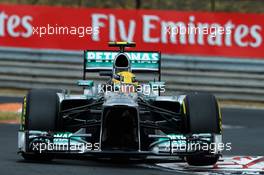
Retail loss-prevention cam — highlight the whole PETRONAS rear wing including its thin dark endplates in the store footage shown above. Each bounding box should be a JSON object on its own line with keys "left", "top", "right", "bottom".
{"left": 83, "top": 50, "right": 161, "bottom": 81}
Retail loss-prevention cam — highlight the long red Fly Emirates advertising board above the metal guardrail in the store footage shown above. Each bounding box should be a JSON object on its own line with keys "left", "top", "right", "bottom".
{"left": 0, "top": 4, "right": 264, "bottom": 58}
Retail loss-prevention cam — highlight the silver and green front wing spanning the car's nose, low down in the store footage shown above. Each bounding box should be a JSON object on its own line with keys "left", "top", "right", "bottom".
{"left": 18, "top": 131, "right": 222, "bottom": 156}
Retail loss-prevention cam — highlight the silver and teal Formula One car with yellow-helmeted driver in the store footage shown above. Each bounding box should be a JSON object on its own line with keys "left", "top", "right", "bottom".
{"left": 18, "top": 42, "right": 222, "bottom": 166}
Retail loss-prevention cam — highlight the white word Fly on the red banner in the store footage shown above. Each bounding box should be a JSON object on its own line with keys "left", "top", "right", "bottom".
{"left": 92, "top": 13, "right": 136, "bottom": 41}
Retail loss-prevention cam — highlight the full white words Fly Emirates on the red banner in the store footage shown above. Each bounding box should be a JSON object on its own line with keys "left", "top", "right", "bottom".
{"left": 92, "top": 13, "right": 263, "bottom": 48}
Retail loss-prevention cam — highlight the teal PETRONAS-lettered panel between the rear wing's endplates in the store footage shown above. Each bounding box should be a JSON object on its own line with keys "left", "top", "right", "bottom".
{"left": 85, "top": 51, "right": 160, "bottom": 71}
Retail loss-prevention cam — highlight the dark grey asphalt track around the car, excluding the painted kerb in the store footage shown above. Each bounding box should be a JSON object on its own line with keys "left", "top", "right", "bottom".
{"left": 0, "top": 98, "right": 264, "bottom": 175}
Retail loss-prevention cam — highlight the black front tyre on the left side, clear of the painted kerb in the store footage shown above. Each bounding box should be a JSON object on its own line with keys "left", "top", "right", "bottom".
{"left": 22, "top": 89, "right": 59, "bottom": 161}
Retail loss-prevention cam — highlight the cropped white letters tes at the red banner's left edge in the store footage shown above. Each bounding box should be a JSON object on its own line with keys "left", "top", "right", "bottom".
{"left": 0, "top": 11, "right": 33, "bottom": 38}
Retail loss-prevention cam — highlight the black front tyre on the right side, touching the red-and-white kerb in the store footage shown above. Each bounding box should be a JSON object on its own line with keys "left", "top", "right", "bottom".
{"left": 184, "top": 93, "right": 221, "bottom": 166}
